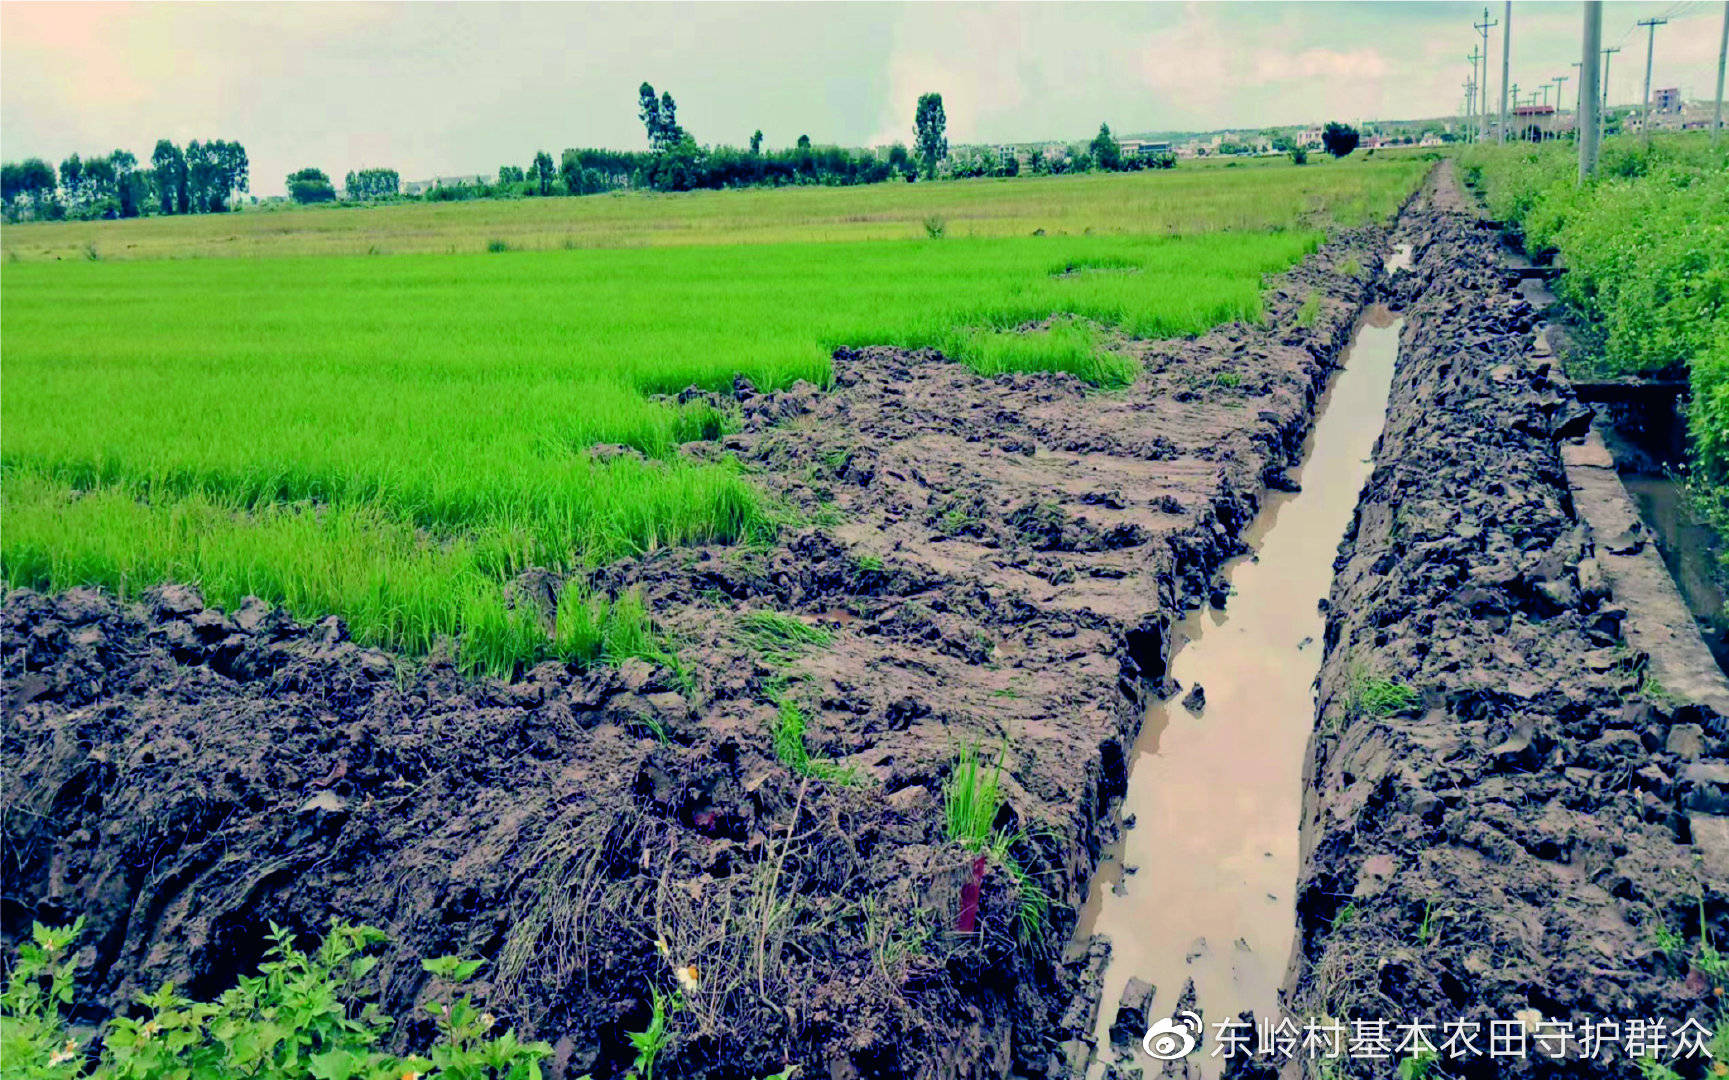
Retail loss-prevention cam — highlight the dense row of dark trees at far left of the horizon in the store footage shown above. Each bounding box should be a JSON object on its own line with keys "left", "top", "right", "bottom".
{"left": 0, "top": 138, "right": 251, "bottom": 221}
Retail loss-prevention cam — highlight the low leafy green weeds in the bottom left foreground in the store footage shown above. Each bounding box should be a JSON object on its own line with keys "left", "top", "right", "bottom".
{"left": 0, "top": 919, "right": 552, "bottom": 1080}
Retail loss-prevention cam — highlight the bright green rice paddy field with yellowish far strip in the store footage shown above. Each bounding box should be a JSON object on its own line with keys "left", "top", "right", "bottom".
{"left": 0, "top": 157, "right": 1428, "bottom": 672}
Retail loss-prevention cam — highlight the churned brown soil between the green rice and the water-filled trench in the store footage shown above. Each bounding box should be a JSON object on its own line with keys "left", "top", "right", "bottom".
{"left": 0, "top": 216, "right": 1385, "bottom": 1078}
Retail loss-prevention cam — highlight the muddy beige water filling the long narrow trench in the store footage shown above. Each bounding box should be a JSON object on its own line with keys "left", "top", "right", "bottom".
{"left": 1079, "top": 300, "right": 1402, "bottom": 1077}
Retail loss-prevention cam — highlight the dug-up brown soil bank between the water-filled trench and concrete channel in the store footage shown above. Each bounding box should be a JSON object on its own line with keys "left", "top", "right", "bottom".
{"left": 1286, "top": 164, "right": 1729, "bottom": 1077}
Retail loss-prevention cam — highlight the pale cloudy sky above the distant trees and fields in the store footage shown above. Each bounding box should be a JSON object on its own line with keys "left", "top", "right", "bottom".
{"left": 0, "top": 0, "right": 1724, "bottom": 195}
